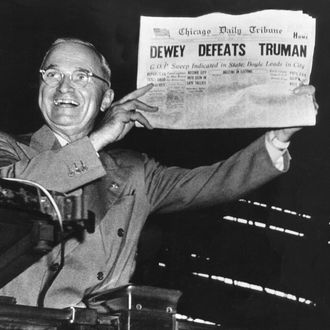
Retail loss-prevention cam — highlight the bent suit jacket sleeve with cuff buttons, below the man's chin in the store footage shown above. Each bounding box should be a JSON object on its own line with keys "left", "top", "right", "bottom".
{"left": 0, "top": 134, "right": 105, "bottom": 192}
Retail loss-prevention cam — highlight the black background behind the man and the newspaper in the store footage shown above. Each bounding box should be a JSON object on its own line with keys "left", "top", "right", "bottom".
{"left": 0, "top": 0, "right": 330, "bottom": 329}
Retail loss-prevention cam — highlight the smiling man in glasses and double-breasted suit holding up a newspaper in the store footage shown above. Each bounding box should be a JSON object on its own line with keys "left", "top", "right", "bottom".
{"left": 0, "top": 39, "right": 314, "bottom": 308}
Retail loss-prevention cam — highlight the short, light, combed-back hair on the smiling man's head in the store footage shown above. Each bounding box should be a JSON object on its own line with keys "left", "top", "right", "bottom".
{"left": 40, "top": 38, "right": 111, "bottom": 83}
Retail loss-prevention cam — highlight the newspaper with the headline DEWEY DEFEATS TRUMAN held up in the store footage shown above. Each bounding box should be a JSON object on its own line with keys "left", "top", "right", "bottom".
{"left": 137, "top": 10, "right": 315, "bottom": 129}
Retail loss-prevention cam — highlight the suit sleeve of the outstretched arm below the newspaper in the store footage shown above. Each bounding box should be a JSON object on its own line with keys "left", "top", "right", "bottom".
{"left": 145, "top": 136, "right": 290, "bottom": 212}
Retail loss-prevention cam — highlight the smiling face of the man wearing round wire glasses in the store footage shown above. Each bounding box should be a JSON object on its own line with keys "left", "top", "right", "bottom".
{"left": 39, "top": 43, "right": 112, "bottom": 140}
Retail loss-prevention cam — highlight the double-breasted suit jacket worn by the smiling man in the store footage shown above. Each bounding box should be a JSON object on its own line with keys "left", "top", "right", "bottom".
{"left": 0, "top": 126, "right": 288, "bottom": 308}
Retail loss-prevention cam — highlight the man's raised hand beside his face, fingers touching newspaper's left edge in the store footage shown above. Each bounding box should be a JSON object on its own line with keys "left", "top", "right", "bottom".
{"left": 90, "top": 84, "right": 158, "bottom": 151}
